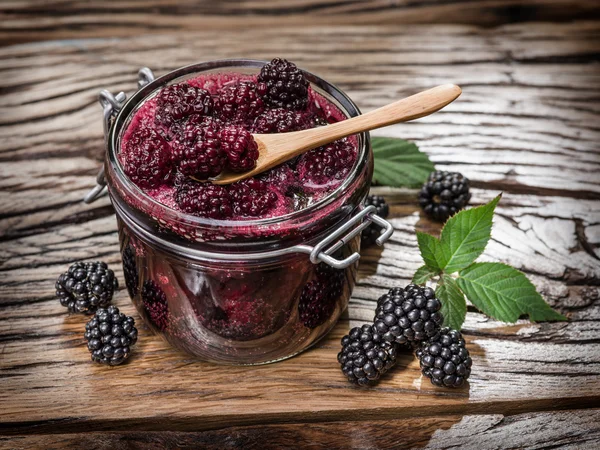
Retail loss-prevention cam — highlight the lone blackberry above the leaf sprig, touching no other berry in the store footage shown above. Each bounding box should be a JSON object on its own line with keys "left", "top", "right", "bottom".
{"left": 419, "top": 171, "right": 471, "bottom": 222}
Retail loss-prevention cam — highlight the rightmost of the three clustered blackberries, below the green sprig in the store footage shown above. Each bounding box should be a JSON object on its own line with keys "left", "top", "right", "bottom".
{"left": 415, "top": 328, "right": 473, "bottom": 387}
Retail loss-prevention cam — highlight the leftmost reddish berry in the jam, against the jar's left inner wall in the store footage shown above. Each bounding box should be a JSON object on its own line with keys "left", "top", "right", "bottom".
{"left": 123, "top": 127, "right": 172, "bottom": 188}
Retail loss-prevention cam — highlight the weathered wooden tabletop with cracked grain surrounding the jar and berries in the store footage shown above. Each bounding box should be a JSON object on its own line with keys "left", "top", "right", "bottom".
{"left": 0, "top": 0, "right": 600, "bottom": 449}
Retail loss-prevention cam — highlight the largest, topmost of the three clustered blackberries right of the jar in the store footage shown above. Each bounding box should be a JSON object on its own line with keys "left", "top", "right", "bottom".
{"left": 373, "top": 284, "right": 444, "bottom": 344}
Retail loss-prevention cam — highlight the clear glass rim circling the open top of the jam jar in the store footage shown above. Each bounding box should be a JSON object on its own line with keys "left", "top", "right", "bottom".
{"left": 107, "top": 58, "right": 370, "bottom": 229}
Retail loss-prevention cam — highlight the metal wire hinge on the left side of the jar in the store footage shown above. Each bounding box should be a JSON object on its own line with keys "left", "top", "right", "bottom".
{"left": 83, "top": 67, "right": 154, "bottom": 204}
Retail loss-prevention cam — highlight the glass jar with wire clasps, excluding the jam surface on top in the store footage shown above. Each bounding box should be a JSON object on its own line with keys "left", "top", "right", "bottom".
{"left": 85, "top": 59, "right": 393, "bottom": 364}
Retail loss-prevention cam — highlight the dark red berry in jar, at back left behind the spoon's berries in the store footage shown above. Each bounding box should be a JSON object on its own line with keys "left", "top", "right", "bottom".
{"left": 154, "top": 83, "right": 213, "bottom": 128}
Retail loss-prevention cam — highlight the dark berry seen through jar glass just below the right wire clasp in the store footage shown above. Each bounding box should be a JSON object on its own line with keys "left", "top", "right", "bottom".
{"left": 298, "top": 263, "right": 345, "bottom": 329}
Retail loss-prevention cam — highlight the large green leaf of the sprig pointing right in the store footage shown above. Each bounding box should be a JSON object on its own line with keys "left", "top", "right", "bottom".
{"left": 457, "top": 263, "right": 566, "bottom": 323}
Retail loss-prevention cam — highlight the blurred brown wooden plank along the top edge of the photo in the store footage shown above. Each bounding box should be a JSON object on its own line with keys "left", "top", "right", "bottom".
{"left": 0, "top": 0, "right": 600, "bottom": 45}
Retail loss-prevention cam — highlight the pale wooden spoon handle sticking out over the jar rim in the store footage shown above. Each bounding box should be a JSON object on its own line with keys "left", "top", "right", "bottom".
{"left": 280, "top": 84, "right": 462, "bottom": 157}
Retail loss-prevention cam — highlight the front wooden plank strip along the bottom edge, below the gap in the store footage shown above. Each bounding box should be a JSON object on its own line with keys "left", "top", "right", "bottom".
{"left": 0, "top": 409, "right": 600, "bottom": 450}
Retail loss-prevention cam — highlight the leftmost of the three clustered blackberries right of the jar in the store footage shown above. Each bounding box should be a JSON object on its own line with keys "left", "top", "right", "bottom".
{"left": 338, "top": 325, "right": 398, "bottom": 386}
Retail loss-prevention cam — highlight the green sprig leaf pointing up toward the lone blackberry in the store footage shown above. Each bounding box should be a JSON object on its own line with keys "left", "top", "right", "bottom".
{"left": 438, "top": 194, "right": 502, "bottom": 273}
